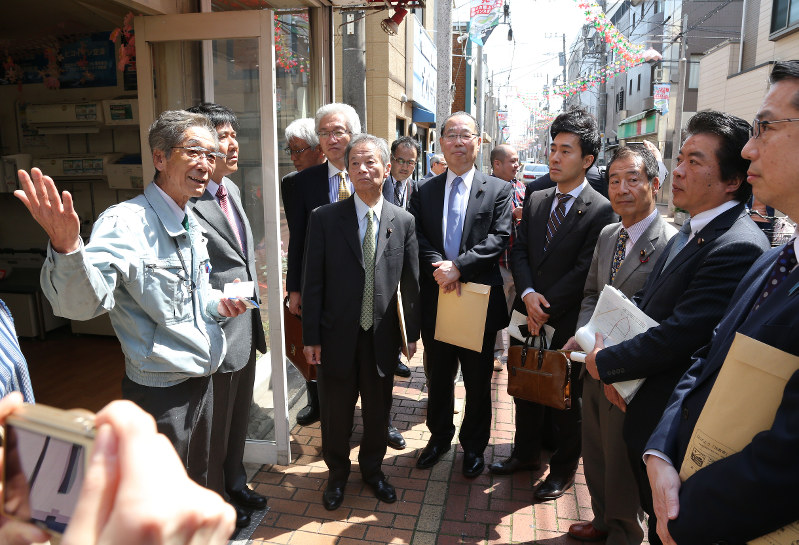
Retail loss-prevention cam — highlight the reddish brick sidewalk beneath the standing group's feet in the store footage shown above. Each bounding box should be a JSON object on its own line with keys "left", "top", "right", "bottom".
{"left": 251, "top": 343, "right": 592, "bottom": 545}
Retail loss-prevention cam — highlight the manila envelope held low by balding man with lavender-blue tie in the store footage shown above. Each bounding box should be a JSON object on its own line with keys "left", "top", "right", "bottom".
{"left": 435, "top": 282, "right": 491, "bottom": 352}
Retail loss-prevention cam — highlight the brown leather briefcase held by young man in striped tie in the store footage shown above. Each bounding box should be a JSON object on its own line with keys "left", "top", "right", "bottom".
{"left": 508, "top": 335, "right": 572, "bottom": 410}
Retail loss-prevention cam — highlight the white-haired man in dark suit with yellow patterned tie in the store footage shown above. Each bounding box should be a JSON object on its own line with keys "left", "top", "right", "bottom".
{"left": 286, "top": 103, "right": 361, "bottom": 426}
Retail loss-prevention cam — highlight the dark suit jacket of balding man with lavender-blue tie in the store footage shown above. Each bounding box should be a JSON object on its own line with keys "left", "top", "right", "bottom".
{"left": 409, "top": 170, "right": 511, "bottom": 336}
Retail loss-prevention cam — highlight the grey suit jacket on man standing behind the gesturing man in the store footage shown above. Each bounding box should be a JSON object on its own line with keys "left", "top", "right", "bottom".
{"left": 193, "top": 178, "right": 266, "bottom": 373}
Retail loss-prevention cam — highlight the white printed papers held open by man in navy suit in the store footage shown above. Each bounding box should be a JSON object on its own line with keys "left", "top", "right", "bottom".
{"left": 574, "top": 285, "right": 658, "bottom": 403}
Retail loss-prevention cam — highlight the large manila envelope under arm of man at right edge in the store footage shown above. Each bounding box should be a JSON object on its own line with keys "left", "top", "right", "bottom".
{"left": 680, "top": 333, "right": 799, "bottom": 545}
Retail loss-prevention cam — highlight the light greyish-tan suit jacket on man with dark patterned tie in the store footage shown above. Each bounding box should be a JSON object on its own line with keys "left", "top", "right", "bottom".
{"left": 577, "top": 214, "right": 677, "bottom": 329}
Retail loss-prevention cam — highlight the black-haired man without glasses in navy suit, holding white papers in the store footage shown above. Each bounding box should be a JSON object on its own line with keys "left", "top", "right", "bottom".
{"left": 586, "top": 111, "right": 768, "bottom": 543}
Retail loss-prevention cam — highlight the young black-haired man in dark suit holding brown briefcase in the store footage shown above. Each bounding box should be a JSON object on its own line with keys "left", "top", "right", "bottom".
{"left": 491, "top": 109, "right": 616, "bottom": 501}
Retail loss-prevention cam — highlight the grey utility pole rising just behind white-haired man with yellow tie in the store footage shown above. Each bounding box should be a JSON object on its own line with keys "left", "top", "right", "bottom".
{"left": 341, "top": 11, "right": 367, "bottom": 132}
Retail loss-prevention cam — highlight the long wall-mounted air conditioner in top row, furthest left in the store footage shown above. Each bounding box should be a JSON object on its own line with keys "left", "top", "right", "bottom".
{"left": 25, "top": 102, "right": 103, "bottom": 134}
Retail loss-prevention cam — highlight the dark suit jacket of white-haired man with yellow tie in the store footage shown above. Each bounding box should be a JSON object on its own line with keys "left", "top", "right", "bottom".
{"left": 286, "top": 161, "right": 330, "bottom": 292}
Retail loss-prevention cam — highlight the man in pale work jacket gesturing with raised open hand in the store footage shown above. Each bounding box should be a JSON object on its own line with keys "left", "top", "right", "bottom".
{"left": 14, "top": 111, "right": 246, "bottom": 486}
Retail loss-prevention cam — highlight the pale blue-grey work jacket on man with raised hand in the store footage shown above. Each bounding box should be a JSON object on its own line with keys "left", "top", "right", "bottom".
{"left": 41, "top": 183, "right": 227, "bottom": 387}
